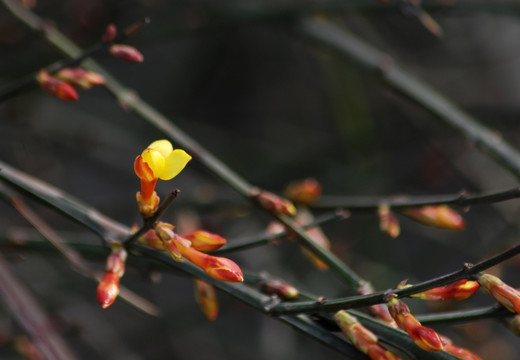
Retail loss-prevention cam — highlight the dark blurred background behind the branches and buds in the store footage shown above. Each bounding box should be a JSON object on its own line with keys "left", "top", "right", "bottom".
{"left": 0, "top": 0, "right": 520, "bottom": 360}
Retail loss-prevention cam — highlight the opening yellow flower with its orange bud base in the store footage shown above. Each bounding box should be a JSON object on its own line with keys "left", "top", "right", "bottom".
{"left": 134, "top": 140, "right": 191, "bottom": 218}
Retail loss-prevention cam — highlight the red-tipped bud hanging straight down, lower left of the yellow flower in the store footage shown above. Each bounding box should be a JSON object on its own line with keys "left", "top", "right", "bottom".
{"left": 96, "top": 243, "right": 127, "bottom": 309}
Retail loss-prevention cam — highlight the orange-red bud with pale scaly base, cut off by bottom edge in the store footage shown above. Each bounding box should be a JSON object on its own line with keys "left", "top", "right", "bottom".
{"left": 334, "top": 310, "right": 400, "bottom": 360}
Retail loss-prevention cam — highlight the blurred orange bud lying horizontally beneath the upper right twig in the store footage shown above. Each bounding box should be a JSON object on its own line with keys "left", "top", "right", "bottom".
{"left": 403, "top": 205, "right": 466, "bottom": 230}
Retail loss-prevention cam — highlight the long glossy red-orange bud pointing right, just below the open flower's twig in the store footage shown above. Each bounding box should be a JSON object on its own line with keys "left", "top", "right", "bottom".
{"left": 177, "top": 243, "right": 244, "bottom": 282}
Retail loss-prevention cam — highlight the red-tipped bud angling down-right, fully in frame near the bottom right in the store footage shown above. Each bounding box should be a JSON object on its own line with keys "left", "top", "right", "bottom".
{"left": 386, "top": 294, "right": 444, "bottom": 351}
